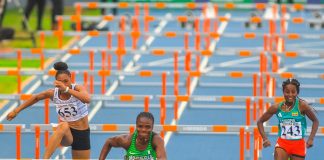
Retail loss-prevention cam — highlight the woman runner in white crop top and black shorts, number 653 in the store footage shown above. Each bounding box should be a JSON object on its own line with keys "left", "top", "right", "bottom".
{"left": 7, "top": 62, "right": 91, "bottom": 159}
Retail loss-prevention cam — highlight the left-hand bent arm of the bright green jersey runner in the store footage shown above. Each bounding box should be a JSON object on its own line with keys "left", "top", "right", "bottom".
{"left": 99, "top": 135, "right": 131, "bottom": 160}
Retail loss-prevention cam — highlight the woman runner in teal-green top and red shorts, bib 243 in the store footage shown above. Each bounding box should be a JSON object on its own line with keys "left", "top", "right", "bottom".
{"left": 257, "top": 79, "right": 319, "bottom": 160}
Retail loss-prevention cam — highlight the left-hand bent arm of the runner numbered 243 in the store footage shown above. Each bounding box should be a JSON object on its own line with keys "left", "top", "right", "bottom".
{"left": 257, "top": 104, "right": 278, "bottom": 147}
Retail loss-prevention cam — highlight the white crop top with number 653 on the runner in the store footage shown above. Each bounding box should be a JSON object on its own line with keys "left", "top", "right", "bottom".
{"left": 53, "top": 84, "right": 88, "bottom": 122}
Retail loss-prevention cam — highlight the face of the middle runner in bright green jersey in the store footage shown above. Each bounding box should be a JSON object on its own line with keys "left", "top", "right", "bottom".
{"left": 136, "top": 117, "right": 153, "bottom": 139}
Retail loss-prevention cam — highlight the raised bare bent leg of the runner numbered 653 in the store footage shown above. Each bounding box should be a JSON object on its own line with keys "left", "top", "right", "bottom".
{"left": 44, "top": 122, "right": 73, "bottom": 159}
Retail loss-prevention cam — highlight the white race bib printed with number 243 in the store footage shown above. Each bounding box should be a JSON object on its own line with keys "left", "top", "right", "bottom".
{"left": 280, "top": 120, "right": 303, "bottom": 139}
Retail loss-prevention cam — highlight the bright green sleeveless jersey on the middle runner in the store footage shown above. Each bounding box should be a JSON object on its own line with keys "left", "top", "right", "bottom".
{"left": 125, "top": 131, "right": 156, "bottom": 160}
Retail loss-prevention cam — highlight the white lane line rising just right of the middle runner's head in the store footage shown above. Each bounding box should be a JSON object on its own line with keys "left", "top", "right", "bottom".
{"left": 164, "top": 14, "right": 231, "bottom": 146}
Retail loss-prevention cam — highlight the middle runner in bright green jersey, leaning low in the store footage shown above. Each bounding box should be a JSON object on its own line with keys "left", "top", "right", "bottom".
{"left": 99, "top": 112, "right": 167, "bottom": 160}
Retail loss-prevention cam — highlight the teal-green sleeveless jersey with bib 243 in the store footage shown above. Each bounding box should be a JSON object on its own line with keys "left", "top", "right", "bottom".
{"left": 276, "top": 98, "right": 307, "bottom": 140}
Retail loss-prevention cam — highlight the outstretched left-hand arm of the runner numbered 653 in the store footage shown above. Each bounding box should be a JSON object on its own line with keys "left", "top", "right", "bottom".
{"left": 7, "top": 89, "right": 54, "bottom": 121}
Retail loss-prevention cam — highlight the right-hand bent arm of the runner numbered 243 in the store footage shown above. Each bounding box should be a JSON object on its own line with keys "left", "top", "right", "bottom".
{"left": 300, "top": 101, "right": 319, "bottom": 148}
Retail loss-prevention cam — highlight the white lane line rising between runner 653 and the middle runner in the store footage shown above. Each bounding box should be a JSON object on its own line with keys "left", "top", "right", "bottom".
{"left": 55, "top": 14, "right": 170, "bottom": 159}
